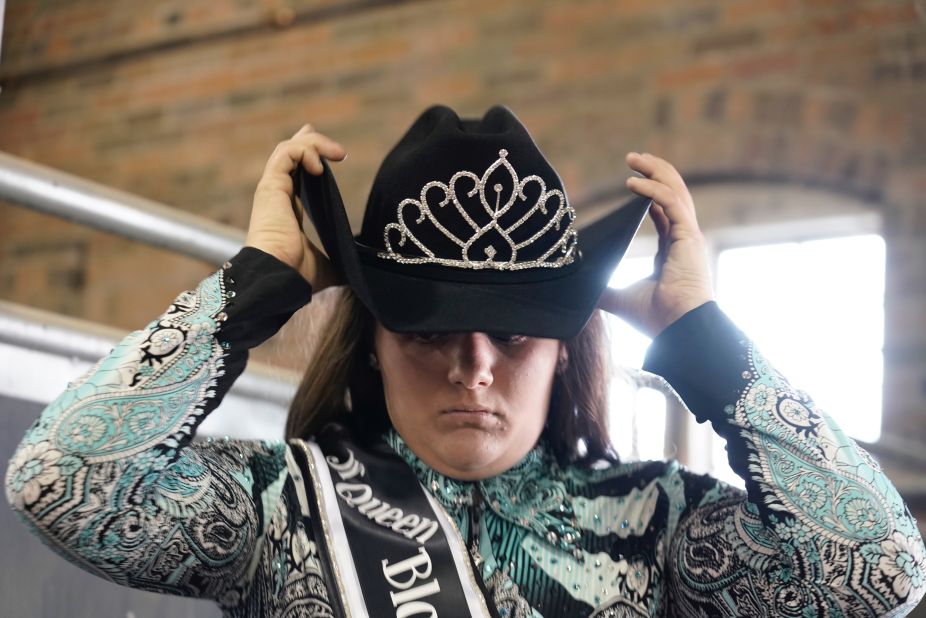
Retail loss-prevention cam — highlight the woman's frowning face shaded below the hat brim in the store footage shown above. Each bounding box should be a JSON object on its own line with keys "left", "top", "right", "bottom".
{"left": 375, "top": 324, "right": 563, "bottom": 480}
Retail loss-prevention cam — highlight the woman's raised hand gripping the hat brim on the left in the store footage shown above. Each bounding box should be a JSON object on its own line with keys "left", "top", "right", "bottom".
{"left": 245, "top": 124, "right": 347, "bottom": 292}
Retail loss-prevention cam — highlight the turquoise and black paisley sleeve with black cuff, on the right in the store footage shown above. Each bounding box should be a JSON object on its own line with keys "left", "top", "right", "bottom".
{"left": 646, "top": 303, "right": 926, "bottom": 617}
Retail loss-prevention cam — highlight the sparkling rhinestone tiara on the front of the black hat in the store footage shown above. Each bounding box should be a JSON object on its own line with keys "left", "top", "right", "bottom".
{"left": 377, "top": 149, "right": 578, "bottom": 270}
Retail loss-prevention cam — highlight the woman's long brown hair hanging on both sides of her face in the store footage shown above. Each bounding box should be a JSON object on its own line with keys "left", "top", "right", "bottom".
{"left": 286, "top": 288, "right": 617, "bottom": 464}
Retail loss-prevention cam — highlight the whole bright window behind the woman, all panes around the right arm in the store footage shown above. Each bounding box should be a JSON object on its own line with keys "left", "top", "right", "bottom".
{"left": 608, "top": 230, "right": 885, "bottom": 486}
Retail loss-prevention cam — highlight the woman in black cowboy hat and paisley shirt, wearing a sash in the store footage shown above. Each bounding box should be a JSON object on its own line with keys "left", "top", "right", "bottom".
{"left": 7, "top": 107, "right": 926, "bottom": 617}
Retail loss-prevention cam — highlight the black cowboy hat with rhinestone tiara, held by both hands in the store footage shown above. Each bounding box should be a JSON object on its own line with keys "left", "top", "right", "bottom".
{"left": 294, "top": 106, "right": 650, "bottom": 339}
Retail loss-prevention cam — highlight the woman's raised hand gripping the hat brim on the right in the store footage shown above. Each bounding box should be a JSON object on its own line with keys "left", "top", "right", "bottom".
{"left": 598, "top": 152, "right": 714, "bottom": 337}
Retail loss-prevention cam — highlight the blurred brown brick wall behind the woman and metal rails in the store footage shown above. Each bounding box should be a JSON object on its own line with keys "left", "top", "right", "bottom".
{"left": 0, "top": 0, "right": 926, "bottom": 462}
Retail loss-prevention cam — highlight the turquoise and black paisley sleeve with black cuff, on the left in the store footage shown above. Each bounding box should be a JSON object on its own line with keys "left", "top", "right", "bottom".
{"left": 6, "top": 247, "right": 311, "bottom": 599}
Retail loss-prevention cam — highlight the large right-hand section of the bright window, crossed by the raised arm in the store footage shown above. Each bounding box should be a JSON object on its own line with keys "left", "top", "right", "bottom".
{"left": 711, "top": 234, "right": 885, "bottom": 485}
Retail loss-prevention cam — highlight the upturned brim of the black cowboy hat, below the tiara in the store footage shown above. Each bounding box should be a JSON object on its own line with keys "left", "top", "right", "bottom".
{"left": 294, "top": 159, "right": 650, "bottom": 339}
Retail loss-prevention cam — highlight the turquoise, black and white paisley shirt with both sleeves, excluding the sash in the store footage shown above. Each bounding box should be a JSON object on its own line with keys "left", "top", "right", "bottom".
{"left": 6, "top": 248, "right": 926, "bottom": 618}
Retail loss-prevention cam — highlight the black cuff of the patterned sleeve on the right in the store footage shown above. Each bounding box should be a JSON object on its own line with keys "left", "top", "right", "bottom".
{"left": 643, "top": 301, "right": 748, "bottom": 422}
